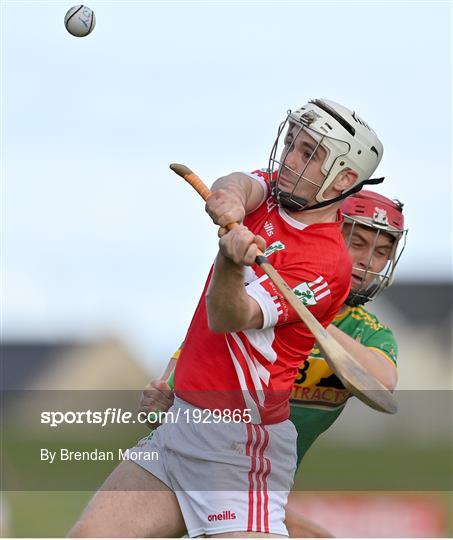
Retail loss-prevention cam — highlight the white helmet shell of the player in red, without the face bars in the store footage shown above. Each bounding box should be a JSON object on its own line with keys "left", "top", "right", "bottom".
{"left": 269, "top": 99, "right": 384, "bottom": 209}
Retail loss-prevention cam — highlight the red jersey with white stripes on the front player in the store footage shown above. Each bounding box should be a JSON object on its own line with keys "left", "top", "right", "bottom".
{"left": 175, "top": 171, "right": 351, "bottom": 424}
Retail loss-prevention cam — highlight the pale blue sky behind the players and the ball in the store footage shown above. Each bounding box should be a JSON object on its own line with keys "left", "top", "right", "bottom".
{"left": 1, "top": 0, "right": 452, "bottom": 368}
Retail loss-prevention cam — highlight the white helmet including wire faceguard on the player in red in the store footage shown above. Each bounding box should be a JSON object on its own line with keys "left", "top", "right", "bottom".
{"left": 269, "top": 99, "right": 383, "bottom": 210}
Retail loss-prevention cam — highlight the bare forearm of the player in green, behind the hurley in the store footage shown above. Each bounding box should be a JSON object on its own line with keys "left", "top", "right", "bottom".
{"left": 327, "top": 324, "right": 398, "bottom": 391}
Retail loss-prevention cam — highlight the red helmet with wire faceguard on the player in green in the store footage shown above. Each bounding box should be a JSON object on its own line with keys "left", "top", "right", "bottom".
{"left": 341, "top": 190, "right": 407, "bottom": 306}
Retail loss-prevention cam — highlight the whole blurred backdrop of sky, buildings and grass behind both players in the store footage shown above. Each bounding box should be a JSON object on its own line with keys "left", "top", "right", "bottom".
{"left": 0, "top": 1, "right": 453, "bottom": 537}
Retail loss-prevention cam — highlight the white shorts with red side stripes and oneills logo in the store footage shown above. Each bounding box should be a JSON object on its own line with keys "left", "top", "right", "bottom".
{"left": 130, "top": 397, "right": 297, "bottom": 537}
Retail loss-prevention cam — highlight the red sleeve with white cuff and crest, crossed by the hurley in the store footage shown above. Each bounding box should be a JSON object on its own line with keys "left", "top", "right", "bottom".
{"left": 246, "top": 270, "right": 332, "bottom": 330}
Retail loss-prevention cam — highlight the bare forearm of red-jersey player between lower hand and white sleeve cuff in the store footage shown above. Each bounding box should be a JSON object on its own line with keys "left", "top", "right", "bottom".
{"left": 206, "top": 253, "right": 260, "bottom": 333}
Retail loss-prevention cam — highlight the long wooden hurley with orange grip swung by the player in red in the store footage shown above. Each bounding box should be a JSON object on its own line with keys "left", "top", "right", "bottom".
{"left": 170, "top": 163, "right": 397, "bottom": 414}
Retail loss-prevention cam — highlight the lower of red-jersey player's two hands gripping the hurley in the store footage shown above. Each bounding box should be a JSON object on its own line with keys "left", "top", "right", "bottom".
{"left": 219, "top": 225, "right": 266, "bottom": 266}
